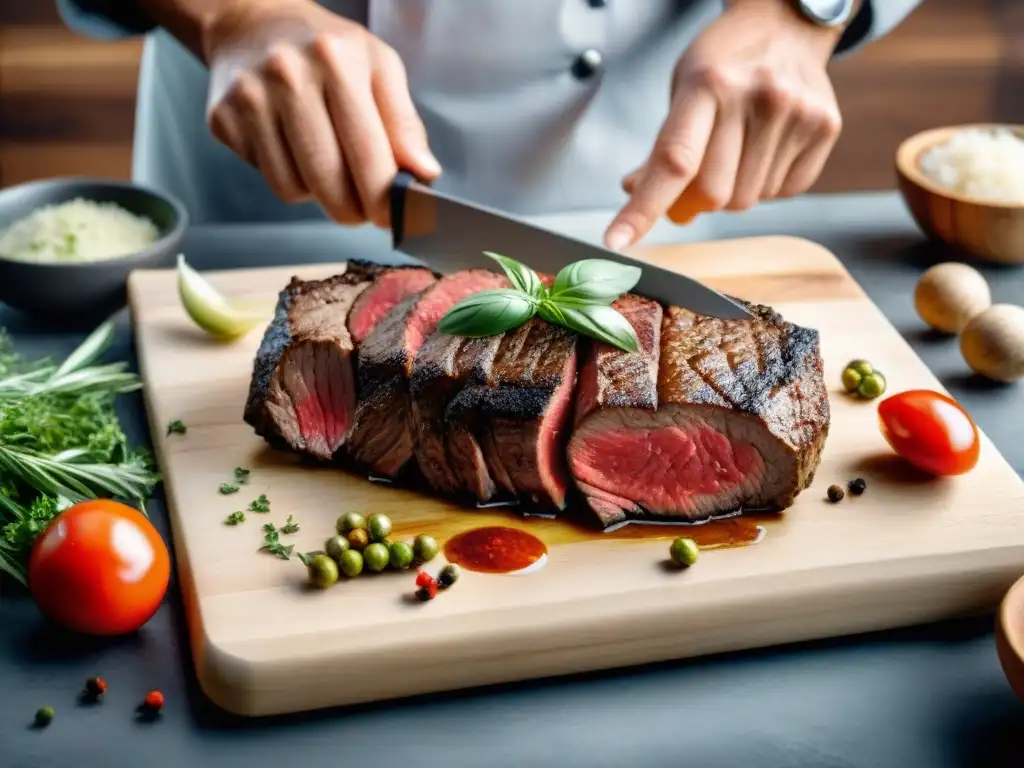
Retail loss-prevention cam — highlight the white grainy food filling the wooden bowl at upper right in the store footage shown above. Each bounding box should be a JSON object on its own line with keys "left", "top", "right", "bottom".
{"left": 921, "top": 128, "right": 1024, "bottom": 203}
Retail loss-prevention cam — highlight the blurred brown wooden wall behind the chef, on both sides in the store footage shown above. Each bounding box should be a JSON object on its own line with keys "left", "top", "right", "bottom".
{"left": 0, "top": 0, "right": 1024, "bottom": 191}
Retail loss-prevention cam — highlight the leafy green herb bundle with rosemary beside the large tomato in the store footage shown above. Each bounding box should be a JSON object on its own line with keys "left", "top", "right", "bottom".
{"left": 0, "top": 323, "right": 160, "bottom": 584}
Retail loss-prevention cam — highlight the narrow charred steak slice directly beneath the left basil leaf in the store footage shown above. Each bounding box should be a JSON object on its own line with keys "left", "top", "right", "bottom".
{"left": 409, "top": 299, "right": 509, "bottom": 494}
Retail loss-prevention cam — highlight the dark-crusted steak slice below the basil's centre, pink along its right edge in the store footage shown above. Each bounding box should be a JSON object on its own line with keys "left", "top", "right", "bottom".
{"left": 446, "top": 317, "right": 577, "bottom": 510}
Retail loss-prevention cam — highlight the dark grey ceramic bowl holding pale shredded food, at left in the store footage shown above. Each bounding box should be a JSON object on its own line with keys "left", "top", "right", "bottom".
{"left": 0, "top": 178, "right": 188, "bottom": 325}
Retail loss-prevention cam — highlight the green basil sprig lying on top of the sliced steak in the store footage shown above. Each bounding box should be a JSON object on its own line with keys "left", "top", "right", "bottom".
{"left": 437, "top": 251, "right": 640, "bottom": 352}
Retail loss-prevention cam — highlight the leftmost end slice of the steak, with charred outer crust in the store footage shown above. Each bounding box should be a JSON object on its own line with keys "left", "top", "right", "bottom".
{"left": 245, "top": 262, "right": 381, "bottom": 460}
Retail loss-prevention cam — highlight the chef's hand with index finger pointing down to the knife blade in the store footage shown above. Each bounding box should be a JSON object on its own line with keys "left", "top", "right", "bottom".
{"left": 605, "top": 0, "right": 842, "bottom": 250}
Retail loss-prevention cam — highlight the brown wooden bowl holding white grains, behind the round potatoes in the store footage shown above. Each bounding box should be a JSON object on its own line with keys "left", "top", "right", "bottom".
{"left": 896, "top": 124, "right": 1024, "bottom": 264}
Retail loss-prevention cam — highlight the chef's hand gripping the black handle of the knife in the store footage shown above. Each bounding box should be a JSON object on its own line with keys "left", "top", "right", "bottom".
{"left": 203, "top": 0, "right": 441, "bottom": 227}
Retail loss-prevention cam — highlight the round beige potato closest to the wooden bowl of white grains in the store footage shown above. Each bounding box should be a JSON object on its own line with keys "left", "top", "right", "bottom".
{"left": 913, "top": 261, "right": 992, "bottom": 334}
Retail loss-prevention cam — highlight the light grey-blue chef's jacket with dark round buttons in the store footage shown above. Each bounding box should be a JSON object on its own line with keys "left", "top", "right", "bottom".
{"left": 58, "top": 0, "right": 920, "bottom": 221}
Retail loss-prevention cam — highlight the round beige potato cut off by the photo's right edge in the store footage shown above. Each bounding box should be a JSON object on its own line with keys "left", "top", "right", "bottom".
{"left": 961, "top": 304, "right": 1024, "bottom": 383}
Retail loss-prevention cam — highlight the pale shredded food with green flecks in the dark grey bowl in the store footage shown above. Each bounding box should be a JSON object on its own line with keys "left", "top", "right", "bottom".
{"left": 0, "top": 198, "right": 160, "bottom": 262}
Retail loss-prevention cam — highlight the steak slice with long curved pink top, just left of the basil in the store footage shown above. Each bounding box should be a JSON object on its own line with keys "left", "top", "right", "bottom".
{"left": 346, "top": 269, "right": 504, "bottom": 477}
